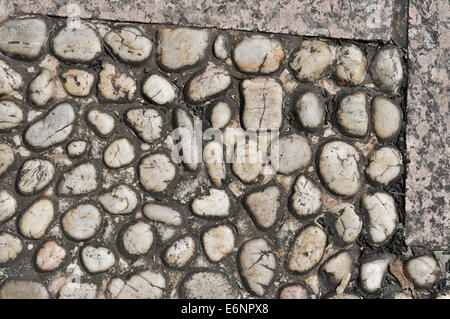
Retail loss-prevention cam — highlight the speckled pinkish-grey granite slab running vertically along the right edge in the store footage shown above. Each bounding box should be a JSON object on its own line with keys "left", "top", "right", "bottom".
{"left": 406, "top": 0, "right": 450, "bottom": 249}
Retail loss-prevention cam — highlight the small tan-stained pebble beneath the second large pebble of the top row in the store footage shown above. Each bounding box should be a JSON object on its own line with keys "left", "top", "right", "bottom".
{"left": 61, "top": 69, "right": 95, "bottom": 97}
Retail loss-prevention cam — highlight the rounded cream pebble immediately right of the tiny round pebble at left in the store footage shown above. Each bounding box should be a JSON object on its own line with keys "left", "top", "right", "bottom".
{"left": 103, "top": 138, "right": 136, "bottom": 168}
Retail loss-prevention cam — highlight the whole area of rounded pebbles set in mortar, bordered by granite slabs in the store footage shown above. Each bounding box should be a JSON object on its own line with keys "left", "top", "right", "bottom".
{"left": 0, "top": 2, "right": 449, "bottom": 299}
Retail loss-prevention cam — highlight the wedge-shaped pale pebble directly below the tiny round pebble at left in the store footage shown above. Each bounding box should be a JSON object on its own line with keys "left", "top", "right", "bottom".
{"left": 58, "top": 163, "right": 98, "bottom": 195}
